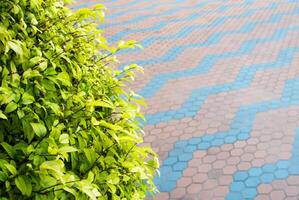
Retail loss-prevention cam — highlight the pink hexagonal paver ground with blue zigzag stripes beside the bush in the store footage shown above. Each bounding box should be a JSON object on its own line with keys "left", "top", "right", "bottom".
{"left": 74, "top": 0, "right": 299, "bottom": 200}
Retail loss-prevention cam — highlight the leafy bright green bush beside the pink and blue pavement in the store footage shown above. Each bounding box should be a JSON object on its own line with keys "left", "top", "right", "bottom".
{"left": 0, "top": 0, "right": 158, "bottom": 200}
